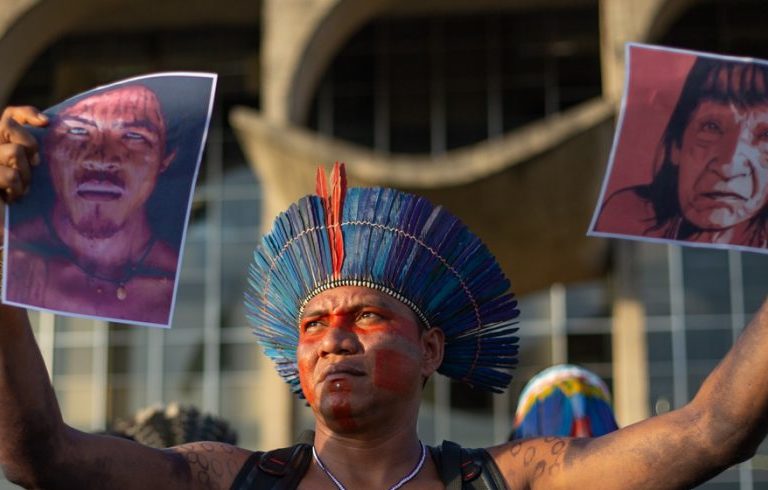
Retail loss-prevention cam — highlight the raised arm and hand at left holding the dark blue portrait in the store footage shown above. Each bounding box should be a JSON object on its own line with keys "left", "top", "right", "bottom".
{"left": 0, "top": 107, "right": 248, "bottom": 490}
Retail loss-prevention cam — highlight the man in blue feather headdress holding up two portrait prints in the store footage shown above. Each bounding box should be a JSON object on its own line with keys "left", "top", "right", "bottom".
{"left": 0, "top": 108, "right": 768, "bottom": 490}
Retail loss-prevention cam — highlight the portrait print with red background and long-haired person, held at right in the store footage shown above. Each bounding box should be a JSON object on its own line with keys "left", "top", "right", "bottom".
{"left": 589, "top": 44, "right": 768, "bottom": 253}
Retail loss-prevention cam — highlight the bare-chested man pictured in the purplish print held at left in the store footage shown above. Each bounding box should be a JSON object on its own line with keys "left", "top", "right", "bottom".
{"left": 5, "top": 84, "right": 178, "bottom": 324}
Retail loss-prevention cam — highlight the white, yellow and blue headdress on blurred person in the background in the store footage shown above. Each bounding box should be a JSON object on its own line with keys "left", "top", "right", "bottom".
{"left": 512, "top": 364, "right": 618, "bottom": 439}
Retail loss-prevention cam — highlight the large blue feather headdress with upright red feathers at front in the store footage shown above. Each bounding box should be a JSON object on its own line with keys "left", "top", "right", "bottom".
{"left": 245, "top": 163, "right": 519, "bottom": 394}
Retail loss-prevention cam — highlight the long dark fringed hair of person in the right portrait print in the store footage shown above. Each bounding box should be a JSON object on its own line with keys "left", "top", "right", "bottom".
{"left": 636, "top": 57, "right": 768, "bottom": 244}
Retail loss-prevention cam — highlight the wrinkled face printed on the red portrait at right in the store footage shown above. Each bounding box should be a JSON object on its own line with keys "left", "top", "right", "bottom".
{"left": 672, "top": 100, "right": 768, "bottom": 230}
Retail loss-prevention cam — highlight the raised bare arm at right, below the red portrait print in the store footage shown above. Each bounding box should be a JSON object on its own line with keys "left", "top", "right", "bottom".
{"left": 490, "top": 301, "right": 768, "bottom": 489}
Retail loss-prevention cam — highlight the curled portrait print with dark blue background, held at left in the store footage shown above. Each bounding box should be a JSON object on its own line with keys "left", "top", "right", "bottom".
{"left": 2, "top": 73, "right": 216, "bottom": 327}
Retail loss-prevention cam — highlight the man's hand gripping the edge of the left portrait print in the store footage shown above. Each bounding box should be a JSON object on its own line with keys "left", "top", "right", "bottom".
{"left": 0, "top": 106, "right": 48, "bottom": 202}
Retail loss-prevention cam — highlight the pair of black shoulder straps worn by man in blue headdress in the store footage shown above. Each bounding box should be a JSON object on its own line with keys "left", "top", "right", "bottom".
{"left": 230, "top": 436, "right": 506, "bottom": 490}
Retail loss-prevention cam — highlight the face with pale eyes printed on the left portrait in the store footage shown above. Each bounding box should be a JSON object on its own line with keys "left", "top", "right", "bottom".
{"left": 45, "top": 85, "right": 173, "bottom": 238}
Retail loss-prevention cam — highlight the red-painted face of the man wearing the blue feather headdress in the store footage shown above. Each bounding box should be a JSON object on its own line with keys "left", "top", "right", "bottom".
{"left": 297, "top": 286, "right": 442, "bottom": 430}
